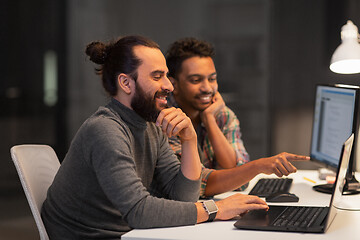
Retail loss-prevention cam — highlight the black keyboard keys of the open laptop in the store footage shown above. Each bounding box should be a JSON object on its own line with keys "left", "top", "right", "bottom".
{"left": 272, "top": 206, "right": 328, "bottom": 227}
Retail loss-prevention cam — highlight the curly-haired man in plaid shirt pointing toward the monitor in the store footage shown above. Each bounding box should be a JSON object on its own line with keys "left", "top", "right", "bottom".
{"left": 166, "top": 38, "right": 309, "bottom": 197}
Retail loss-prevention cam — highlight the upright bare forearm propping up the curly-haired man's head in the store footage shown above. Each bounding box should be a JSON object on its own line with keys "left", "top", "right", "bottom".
{"left": 204, "top": 116, "right": 236, "bottom": 169}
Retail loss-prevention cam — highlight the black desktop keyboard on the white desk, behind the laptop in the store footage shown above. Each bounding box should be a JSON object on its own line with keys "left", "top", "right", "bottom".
{"left": 249, "top": 178, "right": 292, "bottom": 197}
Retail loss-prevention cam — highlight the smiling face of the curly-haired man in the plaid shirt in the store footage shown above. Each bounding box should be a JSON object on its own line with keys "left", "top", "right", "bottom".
{"left": 173, "top": 56, "right": 218, "bottom": 112}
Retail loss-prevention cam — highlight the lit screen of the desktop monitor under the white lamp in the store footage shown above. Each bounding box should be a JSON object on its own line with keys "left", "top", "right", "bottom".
{"left": 310, "top": 85, "right": 358, "bottom": 168}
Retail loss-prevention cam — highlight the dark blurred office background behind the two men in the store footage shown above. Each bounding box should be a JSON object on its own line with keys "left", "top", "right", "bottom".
{"left": 0, "top": 0, "right": 360, "bottom": 238}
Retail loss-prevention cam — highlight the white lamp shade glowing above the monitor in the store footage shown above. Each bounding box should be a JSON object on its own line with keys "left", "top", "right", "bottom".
{"left": 330, "top": 20, "right": 360, "bottom": 74}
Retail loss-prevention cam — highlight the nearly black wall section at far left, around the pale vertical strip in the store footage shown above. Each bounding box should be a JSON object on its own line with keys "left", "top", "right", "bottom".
{"left": 0, "top": 0, "right": 66, "bottom": 195}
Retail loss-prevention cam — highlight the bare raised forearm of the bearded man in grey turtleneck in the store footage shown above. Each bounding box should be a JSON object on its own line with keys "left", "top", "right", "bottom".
{"left": 181, "top": 139, "right": 201, "bottom": 180}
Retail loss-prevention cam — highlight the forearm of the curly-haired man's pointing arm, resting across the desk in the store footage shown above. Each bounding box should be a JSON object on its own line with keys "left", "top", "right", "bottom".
{"left": 205, "top": 161, "right": 261, "bottom": 196}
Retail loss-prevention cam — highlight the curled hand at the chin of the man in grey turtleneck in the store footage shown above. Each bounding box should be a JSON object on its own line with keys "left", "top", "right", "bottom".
{"left": 156, "top": 107, "right": 196, "bottom": 142}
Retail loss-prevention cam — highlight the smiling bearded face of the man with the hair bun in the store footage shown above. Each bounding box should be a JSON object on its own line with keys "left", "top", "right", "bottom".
{"left": 131, "top": 46, "right": 174, "bottom": 122}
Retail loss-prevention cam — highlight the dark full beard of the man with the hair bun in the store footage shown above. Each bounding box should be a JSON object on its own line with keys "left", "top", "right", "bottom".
{"left": 131, "top": 83, "right": 168, "bottom": 122}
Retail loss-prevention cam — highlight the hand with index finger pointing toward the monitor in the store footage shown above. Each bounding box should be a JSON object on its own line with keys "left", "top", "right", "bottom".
{"left": 254, "top": 152, "right": 310, "bottom": 177}
